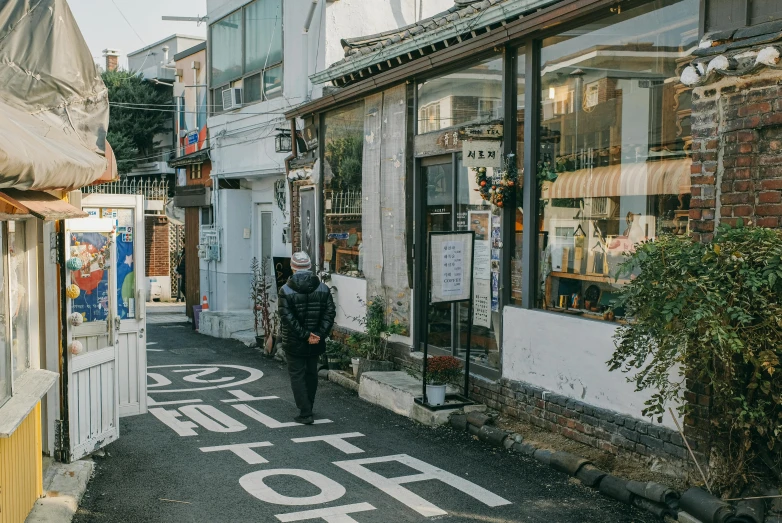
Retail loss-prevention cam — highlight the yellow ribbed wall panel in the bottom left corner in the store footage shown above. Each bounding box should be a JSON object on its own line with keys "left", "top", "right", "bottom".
{"left": 0, "top": 403, "right": 43, "bottom": 523}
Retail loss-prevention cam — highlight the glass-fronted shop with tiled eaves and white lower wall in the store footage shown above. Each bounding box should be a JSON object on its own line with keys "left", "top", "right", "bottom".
{"left": 288, "top": 0, "right": 699, "bottom": 438}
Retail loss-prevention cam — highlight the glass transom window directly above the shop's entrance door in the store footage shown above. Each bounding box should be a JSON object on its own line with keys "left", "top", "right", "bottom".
{"left": 418, "top": 56, "right": 502, "bottom": 134}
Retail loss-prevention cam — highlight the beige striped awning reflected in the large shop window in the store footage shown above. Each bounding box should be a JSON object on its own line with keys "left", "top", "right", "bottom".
{"left": 542, "top": 158, "right": 692, "bottom": 199}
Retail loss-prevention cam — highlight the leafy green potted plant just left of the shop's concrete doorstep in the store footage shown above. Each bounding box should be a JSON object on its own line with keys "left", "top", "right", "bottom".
{"left": 348, "top": 296, "right": 405, "bottom": 379}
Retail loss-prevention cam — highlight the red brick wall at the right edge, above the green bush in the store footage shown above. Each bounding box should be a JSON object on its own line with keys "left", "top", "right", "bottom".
{"left": 690, "top": 71, "right": 782, "bottom": 241}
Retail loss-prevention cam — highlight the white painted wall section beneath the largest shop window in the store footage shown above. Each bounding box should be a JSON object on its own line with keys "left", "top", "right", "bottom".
{"left": 502, "top": 307, "right": 676, "bottom": 429}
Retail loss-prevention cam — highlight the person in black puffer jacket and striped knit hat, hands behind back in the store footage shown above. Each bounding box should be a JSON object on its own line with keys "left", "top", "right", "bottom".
{"left": 279, "top": 252, "right": 337, "bottom": 425}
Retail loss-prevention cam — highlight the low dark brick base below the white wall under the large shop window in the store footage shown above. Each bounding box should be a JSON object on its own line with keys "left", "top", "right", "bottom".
{"left": 391, "top": 345, "right": 688, "bottom": 470}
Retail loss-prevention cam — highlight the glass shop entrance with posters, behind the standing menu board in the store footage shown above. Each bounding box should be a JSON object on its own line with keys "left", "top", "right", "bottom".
{"left": 421, "top": 153, "right": 501, "bottom": 370}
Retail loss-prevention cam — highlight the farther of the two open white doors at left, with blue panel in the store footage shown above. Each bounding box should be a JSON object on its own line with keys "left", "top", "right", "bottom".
{"left": 82, "top": 194, "right": 147, "bottom": 416}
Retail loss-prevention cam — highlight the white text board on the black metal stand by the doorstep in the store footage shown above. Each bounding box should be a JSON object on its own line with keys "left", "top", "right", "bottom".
{"left": 430, "top": 231, "right": 474, "bottom": 303}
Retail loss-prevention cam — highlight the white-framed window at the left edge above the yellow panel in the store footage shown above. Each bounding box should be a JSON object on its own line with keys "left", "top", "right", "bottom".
{"left": 0, "top": 221, "right": 37, "bottom": 405}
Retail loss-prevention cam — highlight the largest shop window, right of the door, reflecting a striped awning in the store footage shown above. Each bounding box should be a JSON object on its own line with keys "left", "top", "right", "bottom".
{"left": 536, "top": 0, "right": 698, "bottom": 320}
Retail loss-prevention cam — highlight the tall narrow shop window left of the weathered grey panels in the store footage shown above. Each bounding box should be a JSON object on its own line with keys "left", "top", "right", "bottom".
{"left": 324, "top": 101, "right": 364, "bottom": 278}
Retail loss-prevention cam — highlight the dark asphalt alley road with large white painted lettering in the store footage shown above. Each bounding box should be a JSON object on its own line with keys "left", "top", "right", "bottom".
{"left": 74, "top": 324, "right": 655, "bottom": 523}
